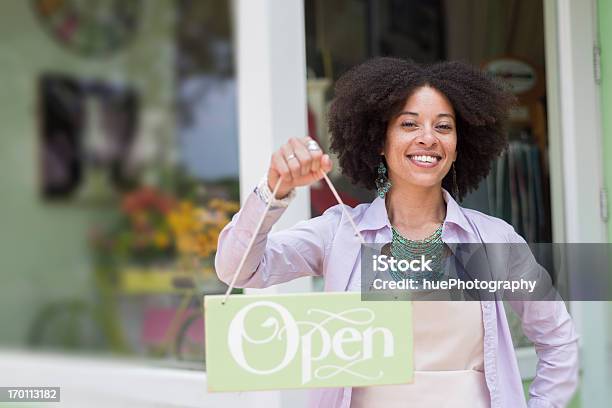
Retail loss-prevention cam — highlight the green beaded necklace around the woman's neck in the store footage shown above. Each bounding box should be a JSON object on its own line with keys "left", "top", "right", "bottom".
{"left": 390, "top": 224, "right": 444, "bottom": 282}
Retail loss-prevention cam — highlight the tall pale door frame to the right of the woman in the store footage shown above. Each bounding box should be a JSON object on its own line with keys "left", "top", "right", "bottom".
{"left": 543, "top": 0, "right": 609, "bottom": 407}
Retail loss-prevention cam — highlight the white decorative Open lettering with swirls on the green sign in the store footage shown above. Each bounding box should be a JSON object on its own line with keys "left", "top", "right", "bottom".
{"left": 228, "top": 301, "right": 395, "bottom": 384}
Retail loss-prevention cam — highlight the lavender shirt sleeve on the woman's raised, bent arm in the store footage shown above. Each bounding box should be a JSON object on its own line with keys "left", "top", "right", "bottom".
{"left": 215, "top": 188, "right": 340, "bottom": 288}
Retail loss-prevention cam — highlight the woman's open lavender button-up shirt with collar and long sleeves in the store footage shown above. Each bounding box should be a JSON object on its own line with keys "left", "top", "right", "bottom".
{"left": 215, "top": 190, "right": 578, "bottom": 408}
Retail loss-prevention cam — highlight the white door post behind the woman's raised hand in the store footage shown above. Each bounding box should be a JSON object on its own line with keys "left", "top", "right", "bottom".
{"left": 233, "top": 0, "right": 312, "bottom": 408}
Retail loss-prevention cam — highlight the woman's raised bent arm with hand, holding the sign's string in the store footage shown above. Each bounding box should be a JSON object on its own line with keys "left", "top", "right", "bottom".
{"left": 215, "top": 138, "right": 334, "bottom": 288}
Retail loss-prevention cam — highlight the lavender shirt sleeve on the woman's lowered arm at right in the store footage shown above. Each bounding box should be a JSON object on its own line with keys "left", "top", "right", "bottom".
{"left": 508, "top": 227, "right": 579, "bottom": 408}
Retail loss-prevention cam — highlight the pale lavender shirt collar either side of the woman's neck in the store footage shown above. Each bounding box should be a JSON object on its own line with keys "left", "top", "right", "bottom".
{"left": 357, "top": 189, "right": 474, "bottom": 234}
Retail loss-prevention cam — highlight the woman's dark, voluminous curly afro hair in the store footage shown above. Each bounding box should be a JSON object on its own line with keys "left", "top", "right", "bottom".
{"left": 329, "top": 57, "right": 515, "bottom": 200}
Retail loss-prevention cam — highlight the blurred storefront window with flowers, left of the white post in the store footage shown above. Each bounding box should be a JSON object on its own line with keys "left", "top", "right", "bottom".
{"left": 0, "top": 0, "right": 239, "bottom": 367}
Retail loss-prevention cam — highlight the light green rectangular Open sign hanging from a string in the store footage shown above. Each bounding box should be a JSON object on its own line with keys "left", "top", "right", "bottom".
{"left": 204, "top": 292, "right": 414, "bottom": 391}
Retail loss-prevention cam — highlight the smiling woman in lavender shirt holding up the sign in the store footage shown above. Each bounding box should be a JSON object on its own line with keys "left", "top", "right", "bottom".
{"left": 216, "top": 58, "right": 578, "bottom": 408}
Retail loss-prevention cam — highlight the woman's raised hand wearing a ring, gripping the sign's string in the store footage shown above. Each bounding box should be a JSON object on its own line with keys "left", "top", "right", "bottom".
{"left": 268, "top": 137, "right": 332, "bottom": 199}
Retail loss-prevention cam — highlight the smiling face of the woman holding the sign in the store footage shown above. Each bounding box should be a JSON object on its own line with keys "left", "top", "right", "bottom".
{"left": 383, "top": 86, "right": 457, "bottom": 188}
